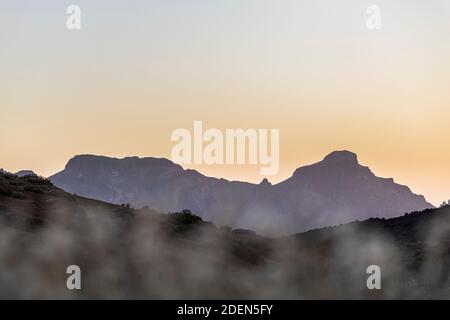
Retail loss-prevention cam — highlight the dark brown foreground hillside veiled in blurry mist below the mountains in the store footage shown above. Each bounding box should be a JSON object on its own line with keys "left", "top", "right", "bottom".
{"left": 0, "top": 173, "right": 450, "bottom": 299}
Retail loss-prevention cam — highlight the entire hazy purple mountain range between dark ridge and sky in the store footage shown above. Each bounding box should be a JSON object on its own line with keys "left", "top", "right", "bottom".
{"left": 50, "top": 151, "right": 432, "bottom": 234}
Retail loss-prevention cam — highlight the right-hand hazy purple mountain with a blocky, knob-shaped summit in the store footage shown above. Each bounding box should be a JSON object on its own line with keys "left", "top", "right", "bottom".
{"left": 276, "top": 151, "right": 433, "bottom": 229}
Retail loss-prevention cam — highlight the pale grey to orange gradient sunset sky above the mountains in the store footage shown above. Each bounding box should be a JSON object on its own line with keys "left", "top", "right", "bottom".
{"left": 0, "top": 0, "right": 450, "bottom": 204}
